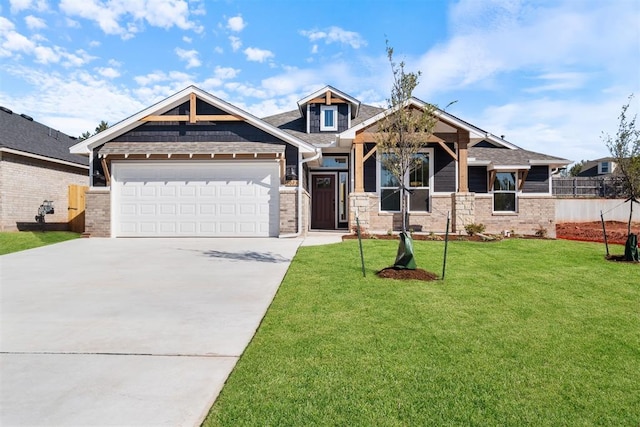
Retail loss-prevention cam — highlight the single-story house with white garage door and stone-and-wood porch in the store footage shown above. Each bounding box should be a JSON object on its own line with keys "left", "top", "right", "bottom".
{"left": 71, "top": 86, "right": 570, "bottom": 237}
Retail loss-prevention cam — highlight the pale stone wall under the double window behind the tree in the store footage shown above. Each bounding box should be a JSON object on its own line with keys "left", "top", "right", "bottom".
{"left": 349, "top": 193, "right": 451, "bottom": 233}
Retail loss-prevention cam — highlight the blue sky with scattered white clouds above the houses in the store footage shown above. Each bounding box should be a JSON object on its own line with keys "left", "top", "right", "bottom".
{"left": 0, "top": 0, "right": 640, "bottom": 165}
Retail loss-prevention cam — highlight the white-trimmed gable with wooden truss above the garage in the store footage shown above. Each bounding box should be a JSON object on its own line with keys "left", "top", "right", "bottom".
{"left": 71, "top": 86, "right": 315, "bottom": 155}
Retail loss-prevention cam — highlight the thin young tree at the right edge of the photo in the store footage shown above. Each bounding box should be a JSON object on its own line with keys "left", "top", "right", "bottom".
{"left": 602, "top": 94, "right": 640, "bottom": 234}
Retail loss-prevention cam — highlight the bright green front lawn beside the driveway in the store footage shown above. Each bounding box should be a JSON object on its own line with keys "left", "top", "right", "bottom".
{"left": 204, "top": 239, "right": 640, "bottom": 426}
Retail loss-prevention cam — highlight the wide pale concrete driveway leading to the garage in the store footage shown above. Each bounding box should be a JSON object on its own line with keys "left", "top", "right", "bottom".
{"left": 0, "top": 238, "right": 302, "bottom": 426}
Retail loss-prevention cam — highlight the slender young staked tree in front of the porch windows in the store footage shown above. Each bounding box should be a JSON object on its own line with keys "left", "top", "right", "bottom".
{"left": 376, "top": 41, "right": 437, "bottom": 232}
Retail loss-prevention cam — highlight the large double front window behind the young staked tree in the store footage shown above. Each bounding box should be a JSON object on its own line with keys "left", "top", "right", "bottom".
{"left": 380, "top": 153, "right": 431, "bottom": 212}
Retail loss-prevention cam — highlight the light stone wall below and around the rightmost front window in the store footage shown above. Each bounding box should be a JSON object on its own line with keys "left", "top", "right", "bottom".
{"left": 475, "top": 194, "right": 556, "bottom": 237}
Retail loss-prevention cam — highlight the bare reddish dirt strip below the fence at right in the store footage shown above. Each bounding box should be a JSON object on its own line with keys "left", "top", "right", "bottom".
{"left": 556, "top": 221, "right": 640, "bottom": 245}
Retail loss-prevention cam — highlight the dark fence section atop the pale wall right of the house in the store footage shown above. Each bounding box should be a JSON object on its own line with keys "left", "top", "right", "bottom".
{"left": 552, "top": 176, "right": 623, "bottom": 199}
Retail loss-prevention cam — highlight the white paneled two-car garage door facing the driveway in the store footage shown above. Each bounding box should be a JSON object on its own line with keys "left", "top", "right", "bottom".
{"left": 111, "top": 162, "right": 279, "bottom": 237}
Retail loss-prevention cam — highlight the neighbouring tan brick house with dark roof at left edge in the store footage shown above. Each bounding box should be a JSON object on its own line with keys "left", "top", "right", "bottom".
{"left": 0, "top": 107, "right": 89, "bottom": 231}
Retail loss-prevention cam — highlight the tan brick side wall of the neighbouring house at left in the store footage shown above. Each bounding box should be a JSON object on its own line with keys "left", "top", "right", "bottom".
{"left": 0, "top": 153, "right": 89, "bottom": 231}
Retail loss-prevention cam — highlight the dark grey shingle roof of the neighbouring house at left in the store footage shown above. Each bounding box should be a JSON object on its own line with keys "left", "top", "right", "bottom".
{"left": 0, "top": 108, "right": 89, "bottom": 166}
